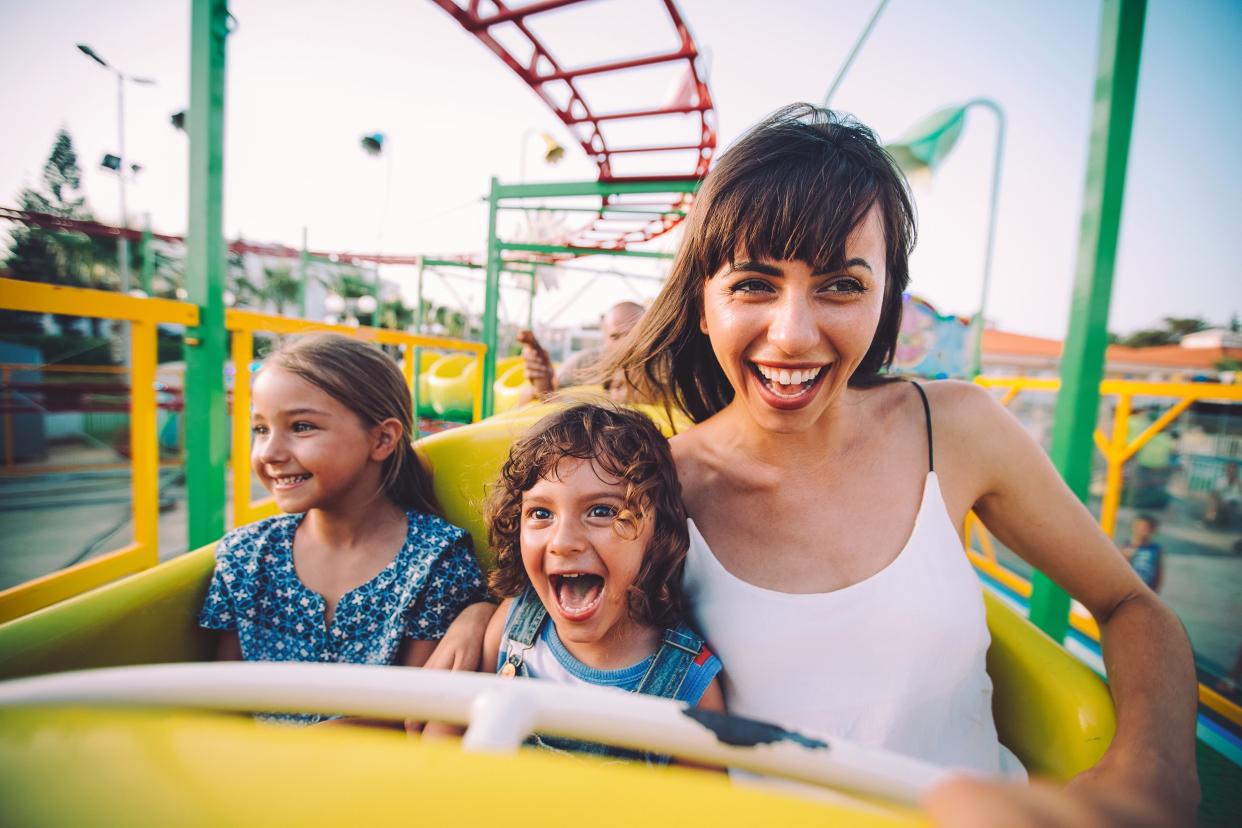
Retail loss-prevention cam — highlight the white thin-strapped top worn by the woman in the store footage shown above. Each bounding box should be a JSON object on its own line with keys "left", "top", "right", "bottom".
{"left": 686, "top": 472, "right": 1025, "bottom": 776}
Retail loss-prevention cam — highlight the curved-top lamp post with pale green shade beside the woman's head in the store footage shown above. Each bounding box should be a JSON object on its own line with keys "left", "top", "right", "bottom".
{"left": 888, "top": 98, "right": 1005, "bottom": 376}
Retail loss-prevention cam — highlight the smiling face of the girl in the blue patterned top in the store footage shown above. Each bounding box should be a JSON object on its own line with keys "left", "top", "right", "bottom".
{"left": 250, "top": 366, "right": 391, "bottom": 513}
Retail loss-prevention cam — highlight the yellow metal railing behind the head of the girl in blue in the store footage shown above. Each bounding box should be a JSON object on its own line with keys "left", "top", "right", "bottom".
{"left": 225, "top": 310, "right": 487, "bottom": 526}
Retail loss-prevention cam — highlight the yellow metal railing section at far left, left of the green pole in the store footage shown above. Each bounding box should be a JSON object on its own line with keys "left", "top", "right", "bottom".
{"left": 0, "top": 278, "right": 199, "bottom": 621}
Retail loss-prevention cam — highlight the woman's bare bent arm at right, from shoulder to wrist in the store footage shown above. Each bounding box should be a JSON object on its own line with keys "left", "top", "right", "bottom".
{"left": 932, "top": 384, "right": 1199, "bottom": 824}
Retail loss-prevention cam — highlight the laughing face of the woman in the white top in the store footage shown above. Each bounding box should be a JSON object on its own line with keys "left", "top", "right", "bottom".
{"left": 699, "top": 207, "right": 887, "bottom": 432}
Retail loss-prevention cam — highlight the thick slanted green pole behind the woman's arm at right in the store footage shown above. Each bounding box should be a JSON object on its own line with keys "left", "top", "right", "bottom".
{"left": 1031, "top": 0, "right": 1146, "bottom": 641}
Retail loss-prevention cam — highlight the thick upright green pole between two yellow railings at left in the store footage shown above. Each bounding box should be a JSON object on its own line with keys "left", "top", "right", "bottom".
{"left": 185, "top": 0, "right": 232, "bottom": 549}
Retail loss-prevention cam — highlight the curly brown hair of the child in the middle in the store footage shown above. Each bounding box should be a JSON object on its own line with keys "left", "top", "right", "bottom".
{"left": 486, "top": 402, "right": 689, "bottom": 627}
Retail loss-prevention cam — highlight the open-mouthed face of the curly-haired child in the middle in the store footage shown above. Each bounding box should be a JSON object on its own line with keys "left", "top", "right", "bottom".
{"left": 520, "top": 458, "right": 655, "bottom": 644}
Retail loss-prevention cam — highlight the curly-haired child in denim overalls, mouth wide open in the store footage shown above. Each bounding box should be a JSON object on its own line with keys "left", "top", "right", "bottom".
{"left": 483, "top": 405, "right": 724, "bottom": 763}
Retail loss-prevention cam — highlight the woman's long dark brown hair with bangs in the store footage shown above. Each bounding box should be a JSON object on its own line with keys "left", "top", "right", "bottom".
{"left": 601, "top": 103, "right": 915, "bottom": 422}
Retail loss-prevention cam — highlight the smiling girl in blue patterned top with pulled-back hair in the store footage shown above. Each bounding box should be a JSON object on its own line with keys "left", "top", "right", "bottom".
{"left": 199, "top": 334, "right": 487, "bottom": 722}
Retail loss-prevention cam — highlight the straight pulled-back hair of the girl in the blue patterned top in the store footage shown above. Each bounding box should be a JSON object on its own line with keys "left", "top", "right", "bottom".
{"left": 263, "top": 334, "right": 442, "bottom": 516}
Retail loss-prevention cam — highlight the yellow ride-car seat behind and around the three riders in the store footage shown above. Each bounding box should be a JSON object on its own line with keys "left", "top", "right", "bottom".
{"left": 0, "top": 405, "right": 1115, "bottom": 781}
